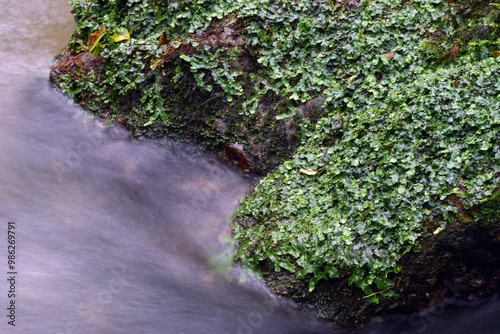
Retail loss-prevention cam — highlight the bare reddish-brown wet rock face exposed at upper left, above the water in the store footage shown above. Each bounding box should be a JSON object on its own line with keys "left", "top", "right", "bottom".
{"left": 51, "top": 17, "right": 308, "bottom": 174}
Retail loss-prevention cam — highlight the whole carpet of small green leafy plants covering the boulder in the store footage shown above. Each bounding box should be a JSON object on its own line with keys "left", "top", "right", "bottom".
{"left": 57, "top": 0, "right": 500, "bottom": 302}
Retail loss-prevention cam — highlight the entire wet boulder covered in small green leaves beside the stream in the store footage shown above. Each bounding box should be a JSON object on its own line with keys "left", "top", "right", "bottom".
{"left": 51, "top": 0, "right": 500, "bottom": 327}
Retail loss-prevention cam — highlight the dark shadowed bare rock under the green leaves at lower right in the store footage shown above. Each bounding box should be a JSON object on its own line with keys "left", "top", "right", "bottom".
{"left": 252, "top": 211, "right": 500, "bottom": 328}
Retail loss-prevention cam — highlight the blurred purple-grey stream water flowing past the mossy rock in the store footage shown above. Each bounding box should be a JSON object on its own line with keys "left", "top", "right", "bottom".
{"left": 0, "top": 0, "right": 500, "bottom": 334}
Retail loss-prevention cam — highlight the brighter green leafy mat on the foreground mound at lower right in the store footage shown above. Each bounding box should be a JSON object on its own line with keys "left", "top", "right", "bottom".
{"left": 236, "top": 59, "right": 500, "bottom": 301}
